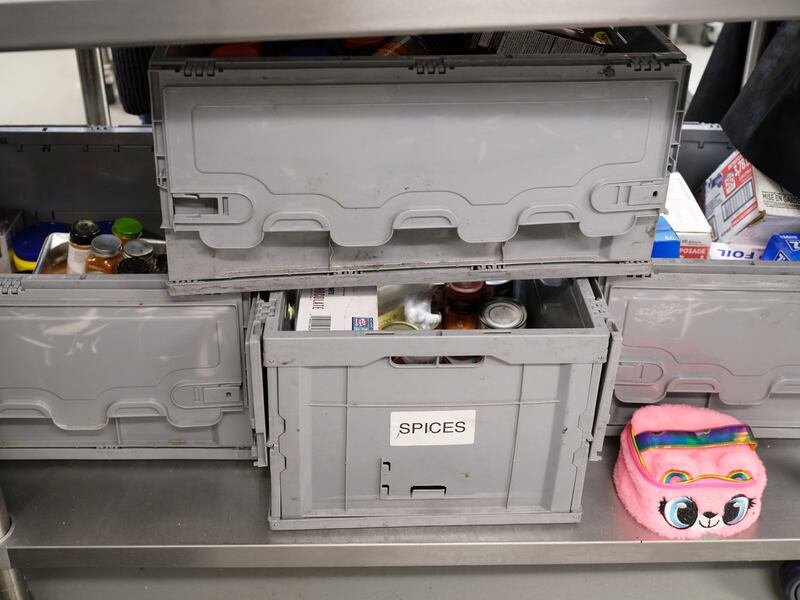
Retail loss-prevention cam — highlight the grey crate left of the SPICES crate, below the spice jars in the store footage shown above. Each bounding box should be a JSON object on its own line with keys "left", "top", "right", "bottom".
{"left": 0, "top": 274, "right": 264, "bottom": 465}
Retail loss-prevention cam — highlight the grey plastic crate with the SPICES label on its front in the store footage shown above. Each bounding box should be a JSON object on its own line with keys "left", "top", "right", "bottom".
{"left": 258, "top": 280, "right": 620, "bottom": 529}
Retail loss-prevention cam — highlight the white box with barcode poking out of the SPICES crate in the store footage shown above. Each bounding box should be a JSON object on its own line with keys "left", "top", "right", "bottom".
{"left": 295, "top": 286, "right": 378, "bottom": 331}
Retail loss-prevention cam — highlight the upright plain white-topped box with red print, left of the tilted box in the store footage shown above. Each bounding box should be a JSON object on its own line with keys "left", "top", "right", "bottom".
{"left": 664, "top": 173, "right": 711, "bottom": 258}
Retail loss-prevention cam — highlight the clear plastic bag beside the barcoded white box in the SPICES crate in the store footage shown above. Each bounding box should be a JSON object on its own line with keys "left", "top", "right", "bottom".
{"left": 378, "top": 284, "right": 442, "bottom": 329}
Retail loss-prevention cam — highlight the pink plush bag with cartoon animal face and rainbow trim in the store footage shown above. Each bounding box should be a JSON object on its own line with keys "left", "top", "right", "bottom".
{"left": 614, "top": 405, "right": 767, "bottom": 539}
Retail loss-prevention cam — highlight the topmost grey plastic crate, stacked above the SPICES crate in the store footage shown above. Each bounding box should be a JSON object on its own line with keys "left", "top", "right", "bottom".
{"left": 151, "top": 28, "right": 689, "bottom": 294}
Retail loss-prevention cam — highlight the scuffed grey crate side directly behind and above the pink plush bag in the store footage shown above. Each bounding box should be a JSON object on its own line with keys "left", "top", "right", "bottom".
{"left": 606, "top": 261, "right": 800, "bottom": 437}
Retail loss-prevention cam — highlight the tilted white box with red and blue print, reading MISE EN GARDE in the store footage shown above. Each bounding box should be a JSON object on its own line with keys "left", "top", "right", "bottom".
{"left": 704, "top": 152, "right": 800, "bottom": 245}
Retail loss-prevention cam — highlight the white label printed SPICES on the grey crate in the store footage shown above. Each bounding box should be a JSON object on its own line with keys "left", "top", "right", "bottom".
{"left": 389, "top": 410, "right": 475, "bottom": 446}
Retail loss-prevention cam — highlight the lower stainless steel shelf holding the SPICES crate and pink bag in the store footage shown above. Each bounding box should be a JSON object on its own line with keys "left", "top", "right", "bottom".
{"left": 0, "top": 440, "right": 800, "bottom": 569}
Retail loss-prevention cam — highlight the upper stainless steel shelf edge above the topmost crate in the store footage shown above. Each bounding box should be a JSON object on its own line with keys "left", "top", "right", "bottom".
{"left": 0, "top": 0, "right": 800, "bottom": 49}
